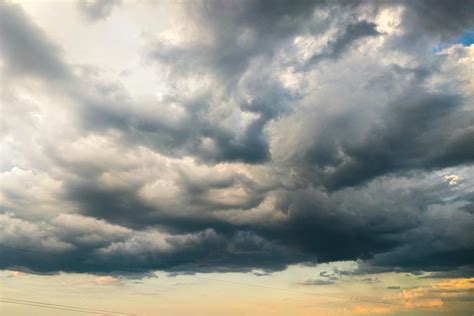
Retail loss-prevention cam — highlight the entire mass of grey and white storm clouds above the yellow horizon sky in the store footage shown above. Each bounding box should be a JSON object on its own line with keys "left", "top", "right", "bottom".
{"left": 0, "top": 1, "right": 474, "bottom": 276}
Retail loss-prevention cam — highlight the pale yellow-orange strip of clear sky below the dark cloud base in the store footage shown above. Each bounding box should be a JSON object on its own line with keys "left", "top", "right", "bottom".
{"left": 0, "top": 262, "right": 474, "bottom": 316}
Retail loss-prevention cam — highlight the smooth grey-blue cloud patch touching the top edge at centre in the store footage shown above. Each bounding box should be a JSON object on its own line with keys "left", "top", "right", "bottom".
{"left": 151, "top": 0, "right": 323, "bottom": 83}
